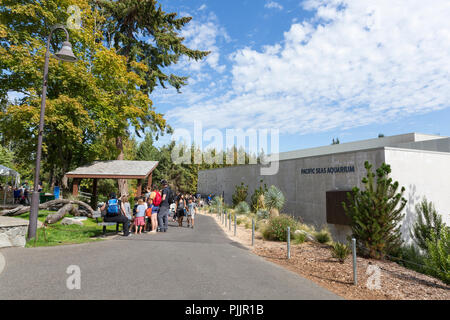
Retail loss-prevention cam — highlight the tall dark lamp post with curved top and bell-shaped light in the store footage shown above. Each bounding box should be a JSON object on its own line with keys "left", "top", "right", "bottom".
{"left": 27, "top": 24, "right": 77, "bottom": 239}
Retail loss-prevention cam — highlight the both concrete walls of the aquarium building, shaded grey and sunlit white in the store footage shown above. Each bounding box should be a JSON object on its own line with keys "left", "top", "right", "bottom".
{"left": 198, "top": 147, "right": 450, "bottom": 242}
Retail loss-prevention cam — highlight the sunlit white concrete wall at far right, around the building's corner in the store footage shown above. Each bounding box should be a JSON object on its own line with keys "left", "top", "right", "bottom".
{"left": 385, "top": 148, "right": 450, "bottom": 242}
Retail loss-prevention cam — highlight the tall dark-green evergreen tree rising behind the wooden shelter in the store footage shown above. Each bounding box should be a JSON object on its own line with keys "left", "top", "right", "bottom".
{"left": 97, "top": 0, "right": 209, "bottom": 194}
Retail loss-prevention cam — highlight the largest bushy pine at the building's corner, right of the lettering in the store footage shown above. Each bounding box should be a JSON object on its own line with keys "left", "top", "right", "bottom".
{"left": 342, "top": 161, "right": 407, "bottom": 259}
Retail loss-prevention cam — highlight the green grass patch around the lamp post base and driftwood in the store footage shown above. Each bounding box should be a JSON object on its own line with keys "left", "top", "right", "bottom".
{"left": 16, "top": 210, "right": 111, "bottom": 248}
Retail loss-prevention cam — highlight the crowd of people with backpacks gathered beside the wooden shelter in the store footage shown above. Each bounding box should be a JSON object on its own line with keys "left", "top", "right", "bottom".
{"left": 100, "top": 180, "right": 203, "bottom": 236}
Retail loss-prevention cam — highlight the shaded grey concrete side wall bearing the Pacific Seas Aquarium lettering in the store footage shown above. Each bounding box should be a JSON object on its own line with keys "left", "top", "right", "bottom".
{"left": 198, "top": 148, "right": 384, "bottom": 241}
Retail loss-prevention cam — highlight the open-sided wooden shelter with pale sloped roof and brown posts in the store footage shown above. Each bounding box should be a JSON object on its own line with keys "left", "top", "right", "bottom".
{"left": 66, "top": 160, "right": 158, "bottom": 205}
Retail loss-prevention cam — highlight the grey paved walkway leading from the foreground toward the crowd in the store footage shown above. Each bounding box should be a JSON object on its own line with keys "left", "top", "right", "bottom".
{"left": 0, "top": 215, "right": 339, "bottom": 300}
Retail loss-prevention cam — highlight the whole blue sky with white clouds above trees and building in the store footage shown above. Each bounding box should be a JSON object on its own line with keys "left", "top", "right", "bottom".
{"left": 152, "top": 0, "right": 450, "bottom": 152}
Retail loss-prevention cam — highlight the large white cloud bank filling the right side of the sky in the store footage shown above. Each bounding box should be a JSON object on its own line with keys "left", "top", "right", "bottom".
{"left": 169, "top": 0, "right": 450, "bottom": 134}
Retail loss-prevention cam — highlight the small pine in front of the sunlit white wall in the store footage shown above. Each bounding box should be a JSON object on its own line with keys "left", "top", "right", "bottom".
{"left": 411, "top": 198, "right": 445, "bottom": 251}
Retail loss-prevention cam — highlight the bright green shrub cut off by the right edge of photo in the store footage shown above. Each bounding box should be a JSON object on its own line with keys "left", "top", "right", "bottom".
{"left": 425, "top": 227, "right": 450, "bottom": 284}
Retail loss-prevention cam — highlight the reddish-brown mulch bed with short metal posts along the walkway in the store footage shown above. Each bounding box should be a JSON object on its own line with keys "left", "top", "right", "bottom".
{"left": 206, "top": 212, "right": 450, "bottom": 300}
